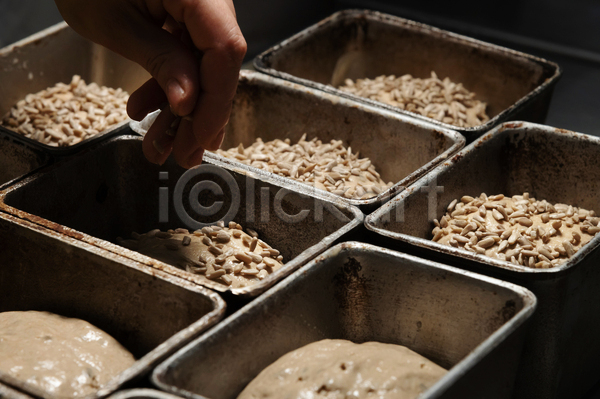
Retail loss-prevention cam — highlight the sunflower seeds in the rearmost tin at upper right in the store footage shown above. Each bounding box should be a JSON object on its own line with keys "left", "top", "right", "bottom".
{"left": 339, "top": 72, "right": 490, "bottom": 127}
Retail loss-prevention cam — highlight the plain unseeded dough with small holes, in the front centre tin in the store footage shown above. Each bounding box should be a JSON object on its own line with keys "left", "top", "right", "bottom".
{"left": 238, "top": 339, "right": 446, "bottom": 399}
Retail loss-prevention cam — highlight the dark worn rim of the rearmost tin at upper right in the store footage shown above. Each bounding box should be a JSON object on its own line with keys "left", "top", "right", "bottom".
{"left": 254, "top": 9, "right": 562, "bottom": 137}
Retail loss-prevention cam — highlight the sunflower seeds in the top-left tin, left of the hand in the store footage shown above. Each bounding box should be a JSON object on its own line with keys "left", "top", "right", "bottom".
{"left": 2, "top": 75, "right": 129, "bottom": 147}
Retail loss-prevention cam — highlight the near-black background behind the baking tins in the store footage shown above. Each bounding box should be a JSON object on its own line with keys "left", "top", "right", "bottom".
{"left": 0, "top": 0, "right": 600, "bottom": 399}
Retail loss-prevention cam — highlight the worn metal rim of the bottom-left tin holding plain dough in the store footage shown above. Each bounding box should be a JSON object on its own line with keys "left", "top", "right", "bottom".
{"left": 0, "top": 212, "right": 226, "bottom": 399}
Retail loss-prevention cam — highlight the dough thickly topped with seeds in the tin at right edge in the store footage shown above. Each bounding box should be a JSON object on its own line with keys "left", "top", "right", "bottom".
{"left": 432, "top": 193, "right": 600, "bottom": 269}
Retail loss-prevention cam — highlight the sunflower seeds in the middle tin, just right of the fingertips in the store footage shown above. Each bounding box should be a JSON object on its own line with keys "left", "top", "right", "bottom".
{"left": 217, "top": 134, "right": 393, "bottom": 199}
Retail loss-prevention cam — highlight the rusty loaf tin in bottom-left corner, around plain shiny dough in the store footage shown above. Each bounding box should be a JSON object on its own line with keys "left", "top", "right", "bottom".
{"left": 0, "top": 213, "right": 225, "bottom": 399}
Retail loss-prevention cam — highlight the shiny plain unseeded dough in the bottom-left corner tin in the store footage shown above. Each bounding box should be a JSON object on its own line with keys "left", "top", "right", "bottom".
{"left": 0, "top": 311, "right": 135, "bottom": 397}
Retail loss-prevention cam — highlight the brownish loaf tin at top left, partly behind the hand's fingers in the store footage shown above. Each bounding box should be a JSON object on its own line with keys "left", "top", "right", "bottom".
{"left": 0, "top": 22, "right": 150, "bottom": 156}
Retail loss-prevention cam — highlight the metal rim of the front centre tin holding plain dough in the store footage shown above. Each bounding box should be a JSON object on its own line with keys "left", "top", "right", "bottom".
{"left": 151, "top": 241, "right": 537, "bottom": 399}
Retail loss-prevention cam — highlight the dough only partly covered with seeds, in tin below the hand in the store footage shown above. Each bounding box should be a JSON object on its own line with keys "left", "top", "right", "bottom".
{"left": 119, "top": 222, "right": 283, "bottom": 288}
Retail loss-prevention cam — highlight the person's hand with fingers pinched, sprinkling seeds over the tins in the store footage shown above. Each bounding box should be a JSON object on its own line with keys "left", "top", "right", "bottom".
{"left": 55, "top": 0, "right": 246, "bottom": 168}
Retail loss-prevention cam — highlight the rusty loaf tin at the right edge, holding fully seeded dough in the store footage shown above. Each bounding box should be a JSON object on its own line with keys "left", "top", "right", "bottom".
{"left": 365, "top": 122, "right": 600, "bottom": 398}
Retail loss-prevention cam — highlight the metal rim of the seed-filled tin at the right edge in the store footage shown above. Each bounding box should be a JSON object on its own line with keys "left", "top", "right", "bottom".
{"left": 365, "top": 122, "right": 600, "bottom": 278}
